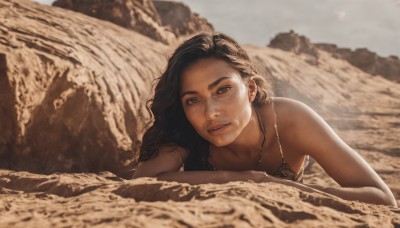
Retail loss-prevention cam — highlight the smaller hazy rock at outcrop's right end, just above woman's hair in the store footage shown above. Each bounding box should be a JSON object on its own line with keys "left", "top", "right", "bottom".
{"left": 153, "top": 0, "right": 214, "bottom": 37}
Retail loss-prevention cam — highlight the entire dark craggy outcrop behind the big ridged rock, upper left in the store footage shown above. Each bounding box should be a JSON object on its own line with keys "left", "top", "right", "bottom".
{"left": 53, "top": 0, "right": 213, "bottom": 44}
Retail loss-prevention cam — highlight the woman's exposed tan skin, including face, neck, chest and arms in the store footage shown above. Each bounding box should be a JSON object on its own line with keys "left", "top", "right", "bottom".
{"left": 134, "top": 58, "right": 397, "bottom": 207}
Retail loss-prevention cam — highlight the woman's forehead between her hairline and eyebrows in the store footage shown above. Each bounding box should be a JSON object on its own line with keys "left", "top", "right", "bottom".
{"left": 180, "top": 58, "right": 241, "bottom": 91}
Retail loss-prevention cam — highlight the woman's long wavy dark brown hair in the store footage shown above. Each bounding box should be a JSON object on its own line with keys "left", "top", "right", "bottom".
{"left": 139, "top": 32, "right": 272, "bottom": 170}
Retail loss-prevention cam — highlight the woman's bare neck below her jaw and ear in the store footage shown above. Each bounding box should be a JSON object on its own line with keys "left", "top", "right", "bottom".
{"left": 227, "top": 108, "right": 265, "bottom": 154}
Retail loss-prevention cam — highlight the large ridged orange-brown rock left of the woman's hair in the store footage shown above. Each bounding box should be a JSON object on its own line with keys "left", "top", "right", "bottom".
{"left": 0, "top": 0, "right": 168, "bottom": 176}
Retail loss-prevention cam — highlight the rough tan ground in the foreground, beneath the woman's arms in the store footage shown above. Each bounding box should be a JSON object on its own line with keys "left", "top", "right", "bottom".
{"left": 0, "top": 170, "right": 400, "bottom": 227}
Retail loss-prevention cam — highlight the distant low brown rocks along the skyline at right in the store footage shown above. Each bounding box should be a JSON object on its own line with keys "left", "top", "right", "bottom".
{"left": 268, "top": 31, "right": 400, "bottom": 82}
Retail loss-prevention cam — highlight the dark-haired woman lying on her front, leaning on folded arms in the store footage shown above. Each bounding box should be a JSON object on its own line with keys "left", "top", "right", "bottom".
{"left": 134, "top": 33, "right": 397, "bottom": 206}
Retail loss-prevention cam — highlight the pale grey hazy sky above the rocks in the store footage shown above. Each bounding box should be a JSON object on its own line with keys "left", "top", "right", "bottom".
{"left": 35, "top": 0, "right": 400, "bottom": 56}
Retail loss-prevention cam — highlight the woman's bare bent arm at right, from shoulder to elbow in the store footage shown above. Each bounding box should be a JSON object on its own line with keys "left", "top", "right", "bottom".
{"left": 277, "top": 99, "right": 397, "bottom": 207}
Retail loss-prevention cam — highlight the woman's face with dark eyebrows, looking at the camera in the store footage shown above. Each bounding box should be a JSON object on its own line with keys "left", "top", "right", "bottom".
{"left": 180, "top": 58, "right": 255, "bottom": 147}
